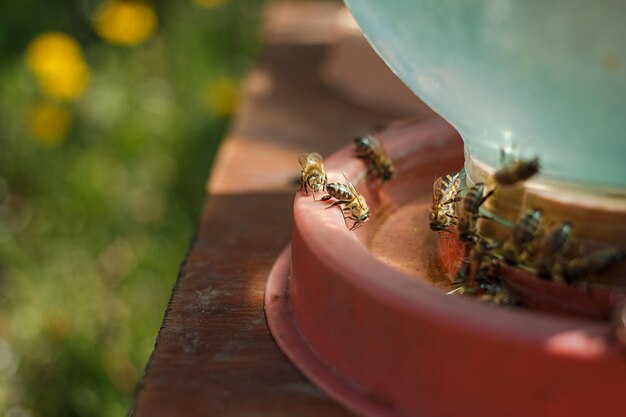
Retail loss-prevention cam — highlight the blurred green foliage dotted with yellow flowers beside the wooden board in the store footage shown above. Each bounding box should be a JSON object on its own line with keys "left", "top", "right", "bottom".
{"left": 0, "top": 0, "right": 262, "bottom": 417}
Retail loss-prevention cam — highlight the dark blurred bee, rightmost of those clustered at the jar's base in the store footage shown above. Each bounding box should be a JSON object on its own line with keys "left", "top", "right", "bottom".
{"left": 563, "top": 248, "right": 626, "bottom": 284}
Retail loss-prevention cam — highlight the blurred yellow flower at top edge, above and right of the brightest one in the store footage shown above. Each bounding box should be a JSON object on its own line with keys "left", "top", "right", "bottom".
{"left": 94, "top": 0, "right": 157, "bottom": 46}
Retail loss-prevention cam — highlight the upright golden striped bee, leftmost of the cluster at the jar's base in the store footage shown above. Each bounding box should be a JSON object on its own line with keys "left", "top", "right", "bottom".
{"left": 428, "top": 172, "right": 461, "bottom": 232}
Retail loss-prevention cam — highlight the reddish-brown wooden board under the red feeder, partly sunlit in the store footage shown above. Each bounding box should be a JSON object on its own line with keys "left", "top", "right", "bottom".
{"left": 132, "top": 2, "right": 431, "bottom": 417}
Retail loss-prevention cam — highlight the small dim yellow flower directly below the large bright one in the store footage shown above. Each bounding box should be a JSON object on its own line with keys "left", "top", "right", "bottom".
{"left": 29, "top": 102, "right": 71, "bottom": 146}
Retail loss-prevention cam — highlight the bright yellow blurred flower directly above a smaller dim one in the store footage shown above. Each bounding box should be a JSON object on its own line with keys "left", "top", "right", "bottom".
{"left": 26, "top": 32, "right": 89, "bottom": 100}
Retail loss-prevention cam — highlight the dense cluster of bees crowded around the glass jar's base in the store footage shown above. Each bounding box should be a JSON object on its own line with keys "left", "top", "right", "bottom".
{"left": 429, "top": 158, "right": 626, "bottom": 304}
